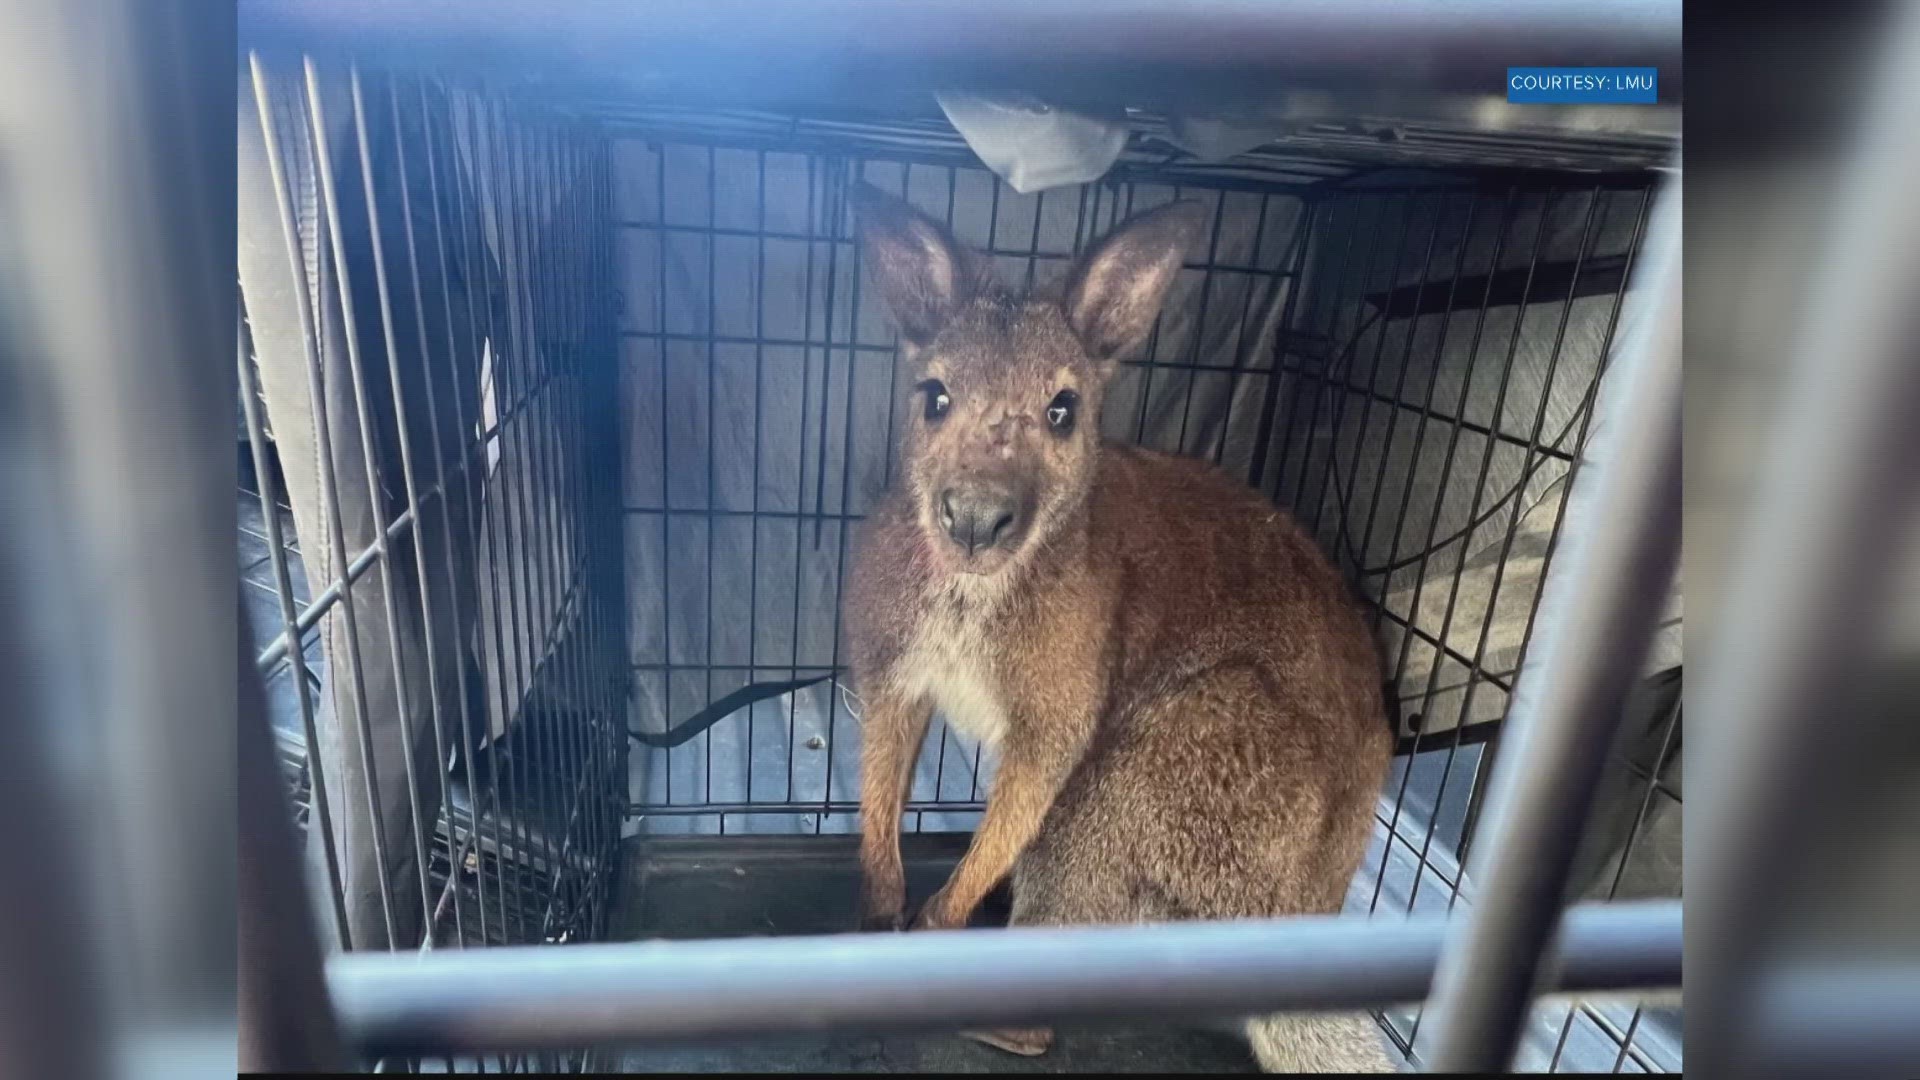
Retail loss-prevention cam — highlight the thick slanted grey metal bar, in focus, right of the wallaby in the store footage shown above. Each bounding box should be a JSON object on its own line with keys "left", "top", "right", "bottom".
{"left": 1428, "top": 170, "right": 1680, "bottom": 1072}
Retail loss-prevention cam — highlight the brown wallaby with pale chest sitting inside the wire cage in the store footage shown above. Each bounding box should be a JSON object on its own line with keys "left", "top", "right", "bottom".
{"left": 845, "top": 184, "right": 1394, "bottom": 1072}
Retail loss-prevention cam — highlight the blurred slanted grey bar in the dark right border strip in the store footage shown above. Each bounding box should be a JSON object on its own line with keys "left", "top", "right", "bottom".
{"left": 1686, "top": 6, "right": 1920, "bottom": 1074}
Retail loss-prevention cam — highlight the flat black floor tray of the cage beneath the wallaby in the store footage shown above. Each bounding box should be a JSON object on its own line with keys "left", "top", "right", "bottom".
{"left": 611, "top": 834, "right": 1256, "bottom": 1072}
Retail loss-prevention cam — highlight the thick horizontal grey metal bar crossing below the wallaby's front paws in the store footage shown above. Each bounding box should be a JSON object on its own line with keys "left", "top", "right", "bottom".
{"left": 326, "top": 901, "right": 1680, "bottom": 1055}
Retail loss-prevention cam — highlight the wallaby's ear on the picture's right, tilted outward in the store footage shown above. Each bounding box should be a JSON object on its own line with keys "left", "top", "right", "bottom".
{"left": 1062, "top": 200, "right": 1206, "bottom": 359}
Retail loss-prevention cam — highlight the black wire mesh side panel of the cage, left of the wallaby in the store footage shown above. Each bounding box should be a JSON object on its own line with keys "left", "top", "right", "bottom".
{"left": 238, "top": 60, "right": 628, "bottom": 1070}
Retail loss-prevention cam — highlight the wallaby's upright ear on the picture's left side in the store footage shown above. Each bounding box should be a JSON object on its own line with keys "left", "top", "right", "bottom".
{"left": 847, "top": 181, "right": 979, "bottom": 346}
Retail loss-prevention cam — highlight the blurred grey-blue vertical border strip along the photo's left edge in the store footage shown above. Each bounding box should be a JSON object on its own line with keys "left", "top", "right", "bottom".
{"left": 0, "top": 0, "right": 238, "bottom": 1076}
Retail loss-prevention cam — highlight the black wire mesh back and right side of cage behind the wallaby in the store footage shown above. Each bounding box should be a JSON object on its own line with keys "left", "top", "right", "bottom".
{"left": 614, "top": 117, "right": 1680, "bottom": 1070}
